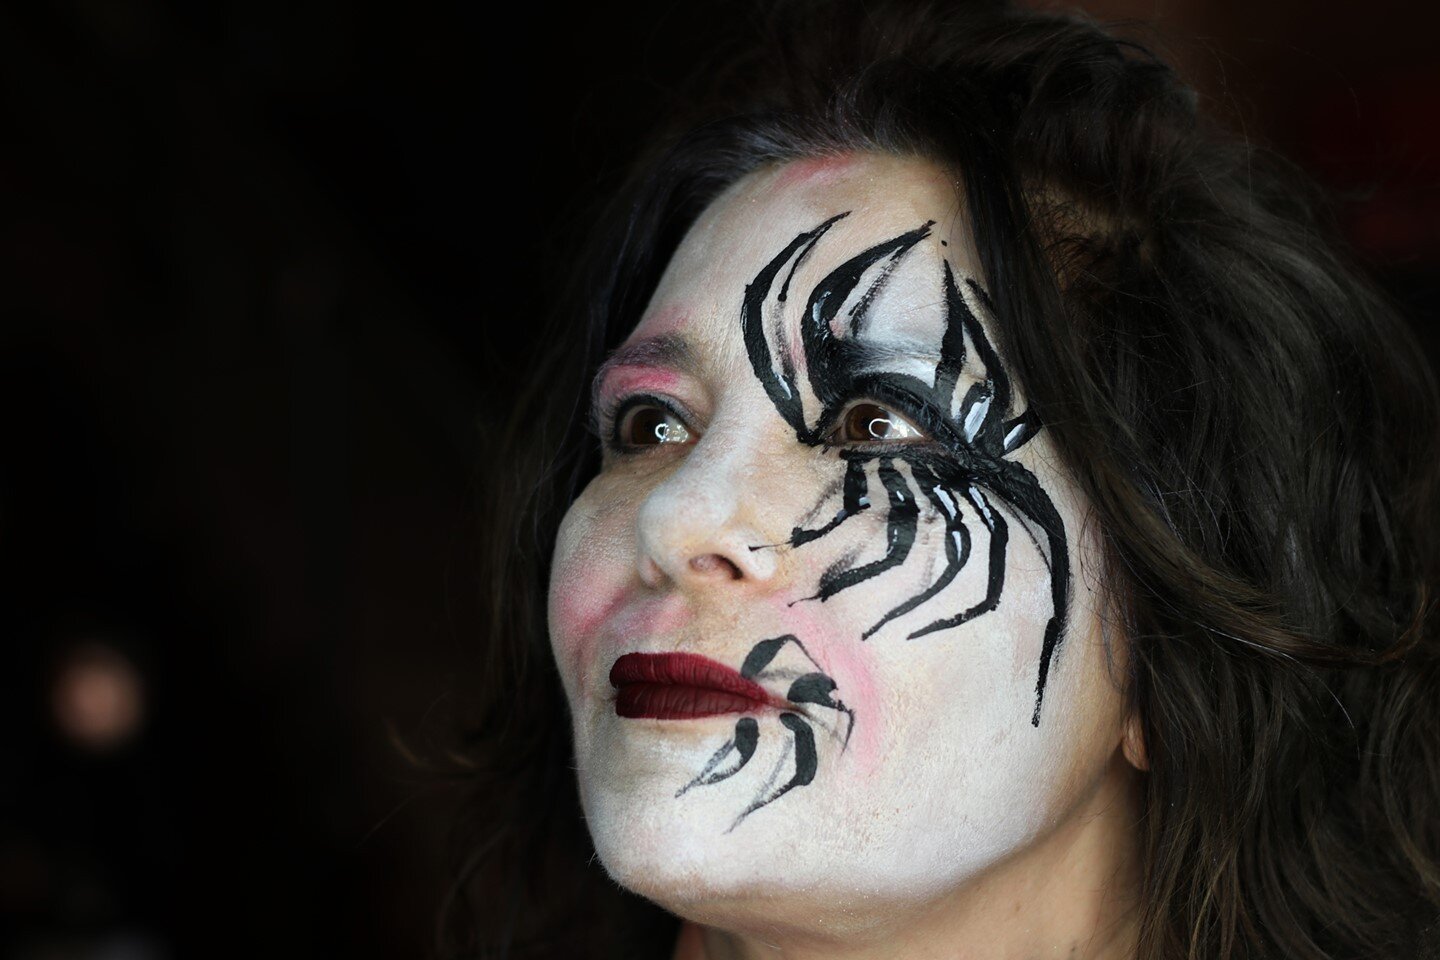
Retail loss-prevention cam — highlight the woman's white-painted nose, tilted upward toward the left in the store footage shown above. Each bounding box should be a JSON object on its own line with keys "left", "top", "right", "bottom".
{"left": 636, "top": 435, "right": 776, "bottom": 590}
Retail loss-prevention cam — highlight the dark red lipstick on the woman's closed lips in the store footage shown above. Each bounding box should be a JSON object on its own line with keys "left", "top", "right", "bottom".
{"left": 611, "top": 653, "right": 786, "bottom": 720}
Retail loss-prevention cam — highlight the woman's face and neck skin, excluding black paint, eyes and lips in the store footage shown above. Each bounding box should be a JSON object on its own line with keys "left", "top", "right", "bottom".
{"left": 550, "top": 154, "right": 1143, "bottom": 960}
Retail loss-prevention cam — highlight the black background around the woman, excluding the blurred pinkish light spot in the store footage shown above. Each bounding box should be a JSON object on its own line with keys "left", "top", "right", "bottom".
{"left": 0, "top": 0, "right": 1440, "bottom": 960}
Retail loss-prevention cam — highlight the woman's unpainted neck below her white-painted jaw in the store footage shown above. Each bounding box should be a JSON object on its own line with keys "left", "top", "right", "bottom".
{"left": 674, "top": 753, "right": 1140, "bottom": 960}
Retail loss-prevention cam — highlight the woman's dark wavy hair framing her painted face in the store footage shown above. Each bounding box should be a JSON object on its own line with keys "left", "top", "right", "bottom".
{"left": 445, "top": 0, "right": 1440, "bottom": 960}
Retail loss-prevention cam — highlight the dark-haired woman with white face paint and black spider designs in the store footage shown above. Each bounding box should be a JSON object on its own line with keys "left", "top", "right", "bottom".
{"left": 461, "top": 3, "right": 1440, "bottom": 960}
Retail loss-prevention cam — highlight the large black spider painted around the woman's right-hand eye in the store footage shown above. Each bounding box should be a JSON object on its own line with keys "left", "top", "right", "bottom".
{"left": 740, "top": 212, "right": 1070, "bottom": 727}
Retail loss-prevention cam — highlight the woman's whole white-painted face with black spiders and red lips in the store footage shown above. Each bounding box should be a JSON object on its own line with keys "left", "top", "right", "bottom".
{"left": 550, "top": 155, "right": 1123, "bottom": 930}
